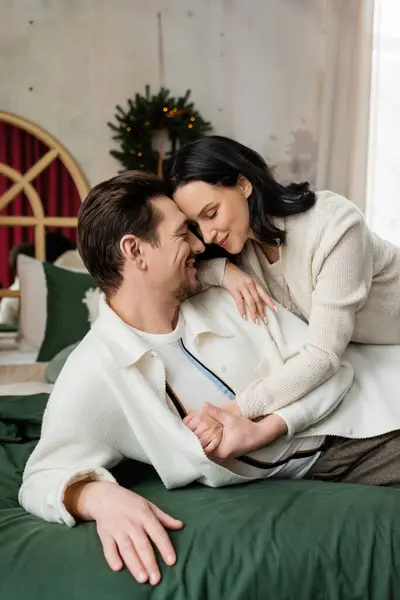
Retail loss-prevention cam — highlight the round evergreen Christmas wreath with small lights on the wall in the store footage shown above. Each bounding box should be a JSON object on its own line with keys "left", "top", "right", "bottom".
{"left": 107, "top": 85, "right": 212, "bottom": 176}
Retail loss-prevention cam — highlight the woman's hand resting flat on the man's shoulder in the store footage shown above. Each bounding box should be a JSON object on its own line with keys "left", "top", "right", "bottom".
{"left": 222, "top": 262, "right": 276, "bottom": 324}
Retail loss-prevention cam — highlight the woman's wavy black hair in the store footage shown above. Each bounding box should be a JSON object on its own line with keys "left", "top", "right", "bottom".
{"left": 166, "top": 135, "right": 316, "bottom": 246}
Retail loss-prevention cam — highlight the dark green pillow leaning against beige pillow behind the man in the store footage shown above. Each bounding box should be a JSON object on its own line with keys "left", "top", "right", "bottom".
{"left": 37, "top": 263, "right": 96, "bottom": 362}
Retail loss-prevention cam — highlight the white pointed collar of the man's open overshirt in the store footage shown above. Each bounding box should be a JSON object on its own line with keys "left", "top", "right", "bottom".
{"left": 93, "top": 297, "right": 233, "bottom": 368}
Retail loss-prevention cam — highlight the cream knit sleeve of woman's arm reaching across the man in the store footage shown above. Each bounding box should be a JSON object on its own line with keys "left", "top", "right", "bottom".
{"left": 236, "top": 203, "right": 372, "bottom": 418}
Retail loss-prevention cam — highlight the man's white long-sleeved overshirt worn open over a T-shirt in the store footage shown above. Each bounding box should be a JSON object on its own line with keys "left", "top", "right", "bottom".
{"left": 19, "top": 288, "right": 400, "bottom": 525}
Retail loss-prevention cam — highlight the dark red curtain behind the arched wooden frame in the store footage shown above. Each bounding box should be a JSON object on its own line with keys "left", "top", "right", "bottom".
{"left": 0, "top": 123, "right": 80, "bottom": 288}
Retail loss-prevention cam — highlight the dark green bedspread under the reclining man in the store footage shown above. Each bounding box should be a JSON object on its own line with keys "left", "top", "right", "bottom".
{"left": 0, "top": 394, "right": 400, "bottom": 600}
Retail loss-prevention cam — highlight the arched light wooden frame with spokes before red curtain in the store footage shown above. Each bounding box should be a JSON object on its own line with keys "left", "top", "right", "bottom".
{"left": 0, "top": 111, "right": 89, "bottom": 297}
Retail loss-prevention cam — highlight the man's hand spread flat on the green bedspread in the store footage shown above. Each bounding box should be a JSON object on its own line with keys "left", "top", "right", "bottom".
{"left": 64, "top": 481, "right": 183, "bottom": 585}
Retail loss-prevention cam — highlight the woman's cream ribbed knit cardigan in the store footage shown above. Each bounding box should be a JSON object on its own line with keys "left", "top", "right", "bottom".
{"left": 201, "top": 191, "right": 400, "bottom": 418}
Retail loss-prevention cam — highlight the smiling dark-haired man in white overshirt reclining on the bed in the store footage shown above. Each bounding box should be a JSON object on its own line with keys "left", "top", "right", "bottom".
{"left": 19, "top": 172, "right": 400, "bottom": 584}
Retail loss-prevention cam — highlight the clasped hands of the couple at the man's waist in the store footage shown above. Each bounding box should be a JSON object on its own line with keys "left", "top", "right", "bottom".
{"left": 183, "top": 402, "right": 287, "bottom": 461}
